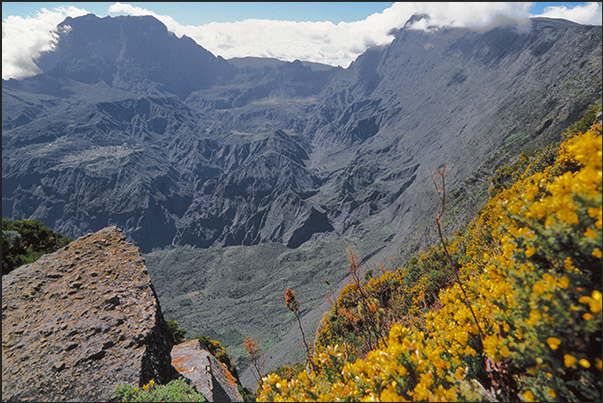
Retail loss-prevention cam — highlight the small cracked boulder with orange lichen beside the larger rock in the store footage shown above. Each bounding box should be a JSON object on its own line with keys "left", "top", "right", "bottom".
{"left": 172, "top": 339, "right": 243, "bottom": 402}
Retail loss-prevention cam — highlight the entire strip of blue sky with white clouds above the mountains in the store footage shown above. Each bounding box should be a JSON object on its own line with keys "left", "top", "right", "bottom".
{"left": 2, "top": 2, "right": 602, "bottom": 79}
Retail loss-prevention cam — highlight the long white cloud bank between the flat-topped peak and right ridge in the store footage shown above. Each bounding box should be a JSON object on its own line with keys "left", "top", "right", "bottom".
{"left": 109, "top": 2, "right": 530, "bottom": 67}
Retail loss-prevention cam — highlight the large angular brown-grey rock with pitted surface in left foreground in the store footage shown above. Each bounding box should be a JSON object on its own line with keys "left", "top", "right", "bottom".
{"left": 2, "top": 227, "right": 179, "bottom": 402}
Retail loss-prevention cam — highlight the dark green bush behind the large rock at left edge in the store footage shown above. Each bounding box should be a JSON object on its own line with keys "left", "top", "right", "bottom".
{"left": 2, "top": 218, "right": 73, "bottom": 275}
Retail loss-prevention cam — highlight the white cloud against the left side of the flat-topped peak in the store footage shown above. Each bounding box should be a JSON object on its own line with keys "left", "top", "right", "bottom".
{"left": 2, "top": 6, "right": 88, "bottom": 80}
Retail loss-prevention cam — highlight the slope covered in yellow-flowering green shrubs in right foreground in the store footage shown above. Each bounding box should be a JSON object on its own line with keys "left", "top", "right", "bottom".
{"left": 258, "top": 106, "right": 603, "bottom": 401}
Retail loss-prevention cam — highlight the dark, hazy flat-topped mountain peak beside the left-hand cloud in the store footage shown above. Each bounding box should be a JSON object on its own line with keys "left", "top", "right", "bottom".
{"left": 38, "top": 14, "right": 236, "bottom": 98}
